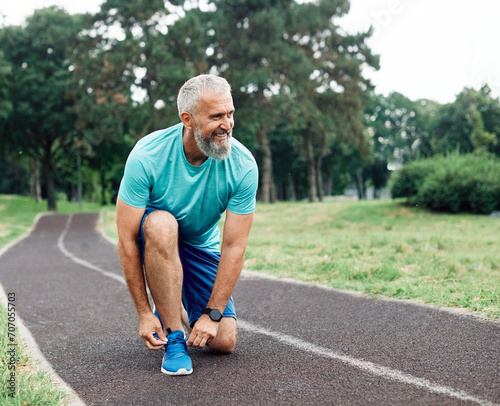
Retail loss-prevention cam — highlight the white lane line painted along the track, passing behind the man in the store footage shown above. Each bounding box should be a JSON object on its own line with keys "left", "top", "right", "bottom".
{"left": 58, "top": 215, "right": 500, "bottom": 406}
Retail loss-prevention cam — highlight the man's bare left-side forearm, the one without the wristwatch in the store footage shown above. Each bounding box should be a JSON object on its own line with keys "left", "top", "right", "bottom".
{"left": 118, "top": 242, "right": 151, "bottom": 316}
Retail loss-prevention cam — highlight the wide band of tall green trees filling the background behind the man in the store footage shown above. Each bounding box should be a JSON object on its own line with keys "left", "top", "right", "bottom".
{"left": 0, "top": 0, "right": 500, "bottom": 210}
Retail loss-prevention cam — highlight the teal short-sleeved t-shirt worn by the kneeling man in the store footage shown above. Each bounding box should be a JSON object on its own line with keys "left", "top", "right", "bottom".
{"left": 118, "top": 123, "right": 258, "bottom": 251}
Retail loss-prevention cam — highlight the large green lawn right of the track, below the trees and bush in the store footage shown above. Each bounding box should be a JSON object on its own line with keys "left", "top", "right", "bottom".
{"left": 99, "top": 200, "right": 500, "bottom": 319}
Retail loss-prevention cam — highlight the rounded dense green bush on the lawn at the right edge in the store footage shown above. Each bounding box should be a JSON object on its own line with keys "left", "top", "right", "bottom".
{"left": 391, "top": 154, "right": 500, "bottom": 214}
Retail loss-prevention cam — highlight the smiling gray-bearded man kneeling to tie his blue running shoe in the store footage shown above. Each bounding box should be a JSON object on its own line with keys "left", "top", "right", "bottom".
{"left": 116, "top": 75, "right": 258, "bottom": 375}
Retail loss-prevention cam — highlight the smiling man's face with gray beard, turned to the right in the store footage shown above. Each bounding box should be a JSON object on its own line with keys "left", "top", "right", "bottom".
{"left": 194, "top": 93, "right": 234, "bottom": 160}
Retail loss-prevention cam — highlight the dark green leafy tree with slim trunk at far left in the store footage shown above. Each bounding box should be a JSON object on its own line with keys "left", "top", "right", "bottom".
{"left": 0, "top": 7, "right": 82, "bottom": 210}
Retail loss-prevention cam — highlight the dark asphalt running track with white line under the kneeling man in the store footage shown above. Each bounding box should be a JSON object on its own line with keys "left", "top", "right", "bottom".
{"left": 0, "top": 214, "right": 500, "bottom": 406}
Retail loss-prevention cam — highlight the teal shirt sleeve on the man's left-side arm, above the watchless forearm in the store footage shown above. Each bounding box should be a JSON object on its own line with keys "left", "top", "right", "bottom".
{"left": 118, "top": 150, "right": 151, "bottom": 208}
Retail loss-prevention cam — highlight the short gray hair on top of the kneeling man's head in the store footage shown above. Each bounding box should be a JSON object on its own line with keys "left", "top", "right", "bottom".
{"left": 177, "top": 75, "right": 231, "bottom": 117}
